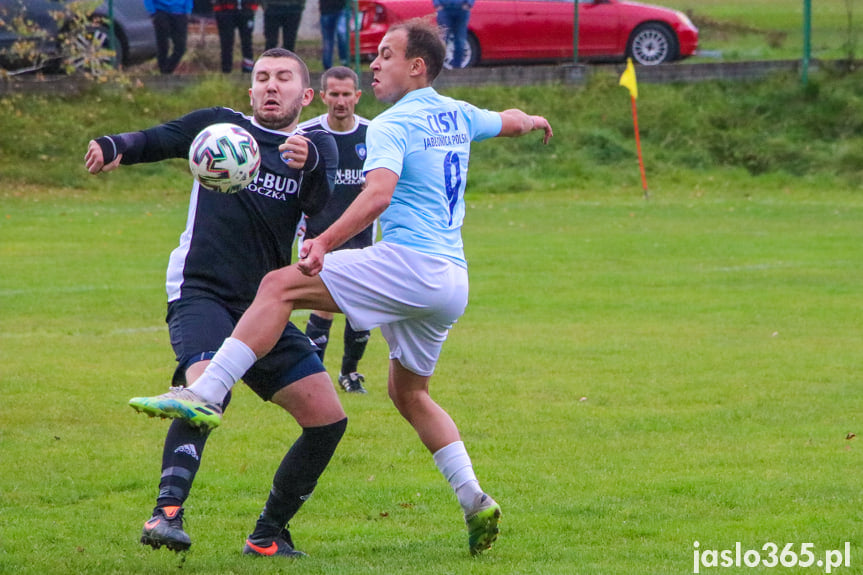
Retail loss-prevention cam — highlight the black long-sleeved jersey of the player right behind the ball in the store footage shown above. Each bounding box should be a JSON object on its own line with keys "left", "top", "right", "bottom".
{"left": 97, "top": 108, "right": 338, "bottom": 307}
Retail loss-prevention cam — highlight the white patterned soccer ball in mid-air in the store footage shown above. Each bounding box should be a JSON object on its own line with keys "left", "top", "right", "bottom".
{"left": 189, "top": 123, "right": 261, "bottom": 194}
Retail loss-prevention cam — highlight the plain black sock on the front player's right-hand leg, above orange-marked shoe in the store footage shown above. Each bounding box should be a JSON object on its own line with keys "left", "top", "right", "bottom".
{"left": 249, "top": 417, "right": 348, "bottom": 541}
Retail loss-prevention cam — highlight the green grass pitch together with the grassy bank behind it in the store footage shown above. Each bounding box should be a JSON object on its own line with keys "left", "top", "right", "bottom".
{"left": 0, "top": 66, "right": 863, "bottom": 575}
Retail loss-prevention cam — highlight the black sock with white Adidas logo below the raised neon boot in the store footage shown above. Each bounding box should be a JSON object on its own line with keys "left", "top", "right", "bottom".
{"left": 156, "top": 393, "right": 231, "bottom": 507}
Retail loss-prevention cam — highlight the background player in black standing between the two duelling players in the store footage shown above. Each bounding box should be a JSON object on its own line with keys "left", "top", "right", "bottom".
{"left": 300, "top": 66, "right": 374, "bottom": 393}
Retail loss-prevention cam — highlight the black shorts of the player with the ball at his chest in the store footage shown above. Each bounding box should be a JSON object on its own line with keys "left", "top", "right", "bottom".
{"left": 166, "top": 294, "right": 326, "bottom": 401}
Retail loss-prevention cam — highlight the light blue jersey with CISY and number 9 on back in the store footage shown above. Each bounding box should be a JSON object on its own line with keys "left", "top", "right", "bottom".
{"left": 363, "top": 88, "right": 502, "bottom": 267}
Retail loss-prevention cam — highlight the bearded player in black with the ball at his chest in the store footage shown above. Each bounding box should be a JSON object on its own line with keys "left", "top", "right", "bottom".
{"left": 85, "top": 48, "right": 347, "bottom": 556}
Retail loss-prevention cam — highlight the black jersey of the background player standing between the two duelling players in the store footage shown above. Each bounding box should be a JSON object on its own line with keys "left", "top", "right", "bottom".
{"left": 300, "top": 114, "right": 374, "bottom": 249}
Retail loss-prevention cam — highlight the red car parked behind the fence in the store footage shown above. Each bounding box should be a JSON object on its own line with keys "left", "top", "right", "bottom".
{"left": 351, "top": 0, "right": 698, "bottom": 66}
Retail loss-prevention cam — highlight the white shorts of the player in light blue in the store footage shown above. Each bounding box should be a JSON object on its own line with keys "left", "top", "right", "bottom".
{"left": 321, "top": 242, "right": 468, "bottom": 375}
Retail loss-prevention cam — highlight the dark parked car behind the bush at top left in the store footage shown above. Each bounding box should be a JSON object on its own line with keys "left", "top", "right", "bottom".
{"left": 0, "top": 0, "right": 156, "bottom": 74}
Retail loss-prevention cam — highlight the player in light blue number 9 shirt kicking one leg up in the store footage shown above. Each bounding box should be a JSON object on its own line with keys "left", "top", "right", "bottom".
{"left": 135, "top": 16, "right": 552, "bottom": 554}
